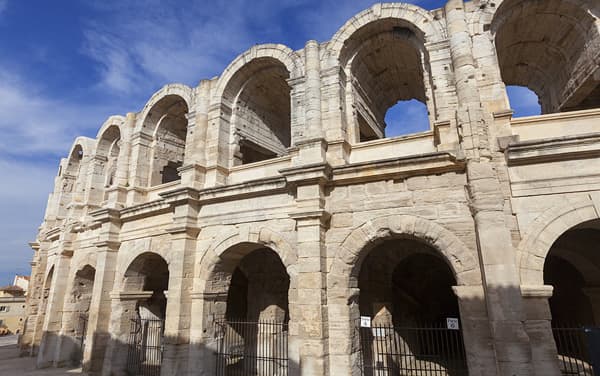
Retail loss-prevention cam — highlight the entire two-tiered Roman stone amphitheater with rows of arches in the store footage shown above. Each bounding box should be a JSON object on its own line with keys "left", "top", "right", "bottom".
{"left": 21, "top": 0, "right": 600, "bottom": 376}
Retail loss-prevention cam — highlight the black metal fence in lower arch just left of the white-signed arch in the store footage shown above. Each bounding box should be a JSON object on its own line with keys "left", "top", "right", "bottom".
{"left": 215, "top": 320, "right": 288, "bottom": 376}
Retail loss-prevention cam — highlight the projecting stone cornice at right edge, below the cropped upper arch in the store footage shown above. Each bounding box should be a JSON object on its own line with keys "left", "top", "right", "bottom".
{"left": 506, "top": 133, "right": 600, "bottom": 166}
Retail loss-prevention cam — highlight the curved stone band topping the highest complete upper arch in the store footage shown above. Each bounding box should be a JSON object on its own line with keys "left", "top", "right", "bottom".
{"left": 327, "top": 3, "right": 447, "bottom": 63}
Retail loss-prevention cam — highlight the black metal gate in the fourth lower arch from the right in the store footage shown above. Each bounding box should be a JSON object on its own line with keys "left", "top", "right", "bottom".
{"left": 127, "top": 318, "right": 165, "bottom": 376}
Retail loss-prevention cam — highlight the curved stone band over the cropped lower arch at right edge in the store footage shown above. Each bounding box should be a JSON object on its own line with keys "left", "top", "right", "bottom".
{"left": 517, "top": 198, "right": 600, "bottom": 286}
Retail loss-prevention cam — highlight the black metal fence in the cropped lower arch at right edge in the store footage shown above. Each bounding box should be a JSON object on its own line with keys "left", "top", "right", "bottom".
{"left": 552, "top": 325, "right": 600, "bottom": 376}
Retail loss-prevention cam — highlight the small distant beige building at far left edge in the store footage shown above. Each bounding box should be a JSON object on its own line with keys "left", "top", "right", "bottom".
{"left": 0, "top": 275, "right": 29, "bottom": 335}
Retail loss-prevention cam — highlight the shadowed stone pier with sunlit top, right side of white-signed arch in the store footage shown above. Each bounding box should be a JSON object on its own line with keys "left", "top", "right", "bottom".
{"left": 452, "top": 286, "right": 496, "bottom": 376}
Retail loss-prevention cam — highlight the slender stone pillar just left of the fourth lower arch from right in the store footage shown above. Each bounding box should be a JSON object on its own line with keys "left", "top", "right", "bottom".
{"left": 83, "top": 209, "right": 121, "bottom": 374}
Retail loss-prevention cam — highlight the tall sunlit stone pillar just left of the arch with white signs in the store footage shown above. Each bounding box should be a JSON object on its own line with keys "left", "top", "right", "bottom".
{"left": 281, "top": 162, "right": 331, "bottom": 376}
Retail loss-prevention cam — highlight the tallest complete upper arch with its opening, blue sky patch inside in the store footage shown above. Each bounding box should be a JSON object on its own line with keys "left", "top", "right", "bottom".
{"left": 327, "top": 4, "right": 446, "bottom": 142}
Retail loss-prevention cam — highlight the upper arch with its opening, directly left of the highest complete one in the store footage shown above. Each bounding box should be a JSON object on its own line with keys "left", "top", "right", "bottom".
{"left": 209, "top": 44, "right": 304, "bottom": 166}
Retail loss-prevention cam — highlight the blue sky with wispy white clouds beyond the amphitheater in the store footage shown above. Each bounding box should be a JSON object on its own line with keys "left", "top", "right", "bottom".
{"left": 0, "top": 0, "right": 540, "bottom": 285}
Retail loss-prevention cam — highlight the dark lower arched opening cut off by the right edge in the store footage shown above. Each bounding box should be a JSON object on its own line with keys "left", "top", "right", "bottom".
{"left": 544, "top": 220, "right": 600, "bottom": 374}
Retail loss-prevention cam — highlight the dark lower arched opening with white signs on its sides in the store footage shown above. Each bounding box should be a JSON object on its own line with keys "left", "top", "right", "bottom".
{"left": 358, "top": 238, "right": 467, "bottom": 375}
